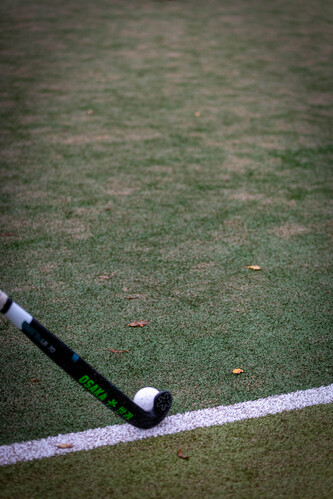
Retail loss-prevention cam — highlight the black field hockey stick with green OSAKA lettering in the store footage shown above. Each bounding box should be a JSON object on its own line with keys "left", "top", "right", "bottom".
{"left": 0, "top": 290, "right": 172, "bottom": 429}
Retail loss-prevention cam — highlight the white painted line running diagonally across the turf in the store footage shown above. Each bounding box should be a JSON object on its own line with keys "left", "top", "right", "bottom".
{"left": 0, "top": 384, "right": 333, "bottom": 465}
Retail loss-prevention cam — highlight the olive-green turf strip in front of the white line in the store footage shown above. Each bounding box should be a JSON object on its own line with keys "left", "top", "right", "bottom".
{"left": 0, "top": 404, "right": 333, "bottom": 498}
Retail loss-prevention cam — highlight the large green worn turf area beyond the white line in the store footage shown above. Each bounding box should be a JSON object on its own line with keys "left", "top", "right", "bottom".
{"left": 0, "top": 0, "right": 333, "bottom": 443}
